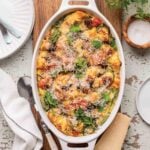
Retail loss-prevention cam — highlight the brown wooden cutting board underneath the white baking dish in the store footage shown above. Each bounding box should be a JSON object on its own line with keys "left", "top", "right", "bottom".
{"left": 33, "top": 0, "right": 122, "bottom": 150}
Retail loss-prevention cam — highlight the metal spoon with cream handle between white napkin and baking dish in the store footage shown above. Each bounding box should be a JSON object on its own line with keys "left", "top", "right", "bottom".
{"left": 17, "top": 76, "right": 58, "bottom": 150}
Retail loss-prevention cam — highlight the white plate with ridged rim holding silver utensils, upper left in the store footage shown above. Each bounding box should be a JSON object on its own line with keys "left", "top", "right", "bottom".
{"left": 0, "top": 0, "right": 35, "bottom": 59}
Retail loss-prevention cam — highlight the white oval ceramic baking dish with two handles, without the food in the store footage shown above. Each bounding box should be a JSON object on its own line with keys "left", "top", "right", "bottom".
{"left": 32, "top": 0, "right": 125, "bottom": 150}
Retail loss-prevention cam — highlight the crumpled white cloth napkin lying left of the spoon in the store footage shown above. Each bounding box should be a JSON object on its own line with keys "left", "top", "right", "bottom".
{"left": 0, "top": 69, "right": 43, "bottom": 150}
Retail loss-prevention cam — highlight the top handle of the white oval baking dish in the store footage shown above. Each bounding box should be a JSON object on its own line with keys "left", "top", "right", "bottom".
{"left": 59, "top": 0, "right": 98, "bottom": 10}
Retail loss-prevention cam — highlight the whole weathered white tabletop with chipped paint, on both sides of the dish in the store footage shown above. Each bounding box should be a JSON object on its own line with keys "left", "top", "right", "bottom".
{"left": 0, "top": 2, "right": 150, "bottom": 150}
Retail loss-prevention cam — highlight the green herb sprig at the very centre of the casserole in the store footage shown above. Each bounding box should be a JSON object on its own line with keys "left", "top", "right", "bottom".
{"left": 75, "top": 57, "right": 87, "bottom": 78}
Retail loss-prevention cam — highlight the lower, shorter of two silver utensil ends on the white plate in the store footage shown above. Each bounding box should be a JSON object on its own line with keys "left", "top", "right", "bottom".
{"left": 0, "top": 24, "right": 12, "bottom": 44}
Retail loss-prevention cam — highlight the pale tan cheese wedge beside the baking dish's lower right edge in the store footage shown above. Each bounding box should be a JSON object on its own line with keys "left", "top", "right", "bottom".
{"left": 95, "top": 113, "right": 131, "bottom": 150}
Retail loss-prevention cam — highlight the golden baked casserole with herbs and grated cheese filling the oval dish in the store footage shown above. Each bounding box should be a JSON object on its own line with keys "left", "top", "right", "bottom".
{"left": 36, "top": 11, "right": 121, "bottom": 136}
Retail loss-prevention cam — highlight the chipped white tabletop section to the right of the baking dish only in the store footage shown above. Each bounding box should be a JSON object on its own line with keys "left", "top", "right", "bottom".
{"left": 121, "top": 0, "right": 150, "bottom": 150}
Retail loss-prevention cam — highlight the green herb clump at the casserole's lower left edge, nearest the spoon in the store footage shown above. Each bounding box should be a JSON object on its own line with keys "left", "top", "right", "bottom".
{"left": 44, "top": 91, "right": 58, "bottom": 108}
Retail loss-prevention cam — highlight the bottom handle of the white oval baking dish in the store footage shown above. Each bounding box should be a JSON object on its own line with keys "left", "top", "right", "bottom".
{"left": 59, "top": 139, "right": 97, "bottom": 150}
